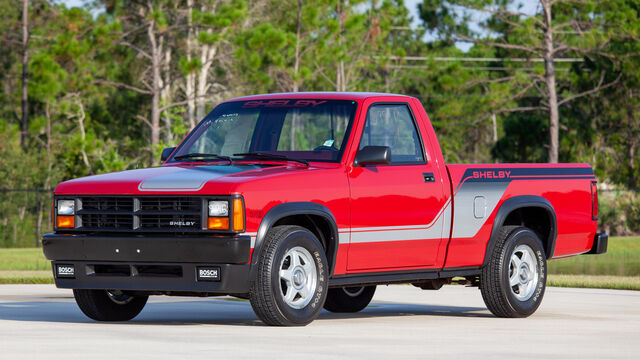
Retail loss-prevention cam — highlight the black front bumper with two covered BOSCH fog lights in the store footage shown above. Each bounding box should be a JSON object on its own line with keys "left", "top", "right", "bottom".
{"left": 42, "top": 234, "right": 251, "bottom": 294}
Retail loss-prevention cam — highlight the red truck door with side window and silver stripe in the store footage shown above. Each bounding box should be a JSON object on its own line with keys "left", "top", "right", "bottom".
{"left": 347, "top": 103, "right": 446, "bottom": 272}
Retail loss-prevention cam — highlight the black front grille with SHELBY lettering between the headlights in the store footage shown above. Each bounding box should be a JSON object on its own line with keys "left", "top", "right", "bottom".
{"left": 75, "top": 196, "right": 203, "bottom": 233}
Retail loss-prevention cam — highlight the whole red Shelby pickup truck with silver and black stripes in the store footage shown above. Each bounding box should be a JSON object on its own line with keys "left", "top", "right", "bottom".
{"left": 43, "top": 93, "right": 607, "bottom": 325}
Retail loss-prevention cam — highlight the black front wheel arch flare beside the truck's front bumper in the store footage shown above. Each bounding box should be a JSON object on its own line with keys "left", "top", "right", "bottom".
{"left": 250, "top": 202, "right": 339, "bottom": 278}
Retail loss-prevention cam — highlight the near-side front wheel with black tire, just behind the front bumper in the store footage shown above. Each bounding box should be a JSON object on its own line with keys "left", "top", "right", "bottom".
{"left": 249, "top": 225, "right": 328, "bottom": 326}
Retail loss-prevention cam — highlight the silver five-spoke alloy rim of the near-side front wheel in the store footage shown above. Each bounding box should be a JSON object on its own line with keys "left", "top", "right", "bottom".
{"left": 279, "top": 246, "right": 318, "bottom": 309}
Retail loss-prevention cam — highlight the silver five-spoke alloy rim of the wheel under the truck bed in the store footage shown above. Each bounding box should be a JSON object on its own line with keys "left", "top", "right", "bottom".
{"left": 509, "top": 244, "right": 539, "bottom": 301}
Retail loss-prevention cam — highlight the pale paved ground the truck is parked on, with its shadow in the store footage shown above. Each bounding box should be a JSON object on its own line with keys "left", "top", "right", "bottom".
{"left": 0, "top": 285, "right": 640, "bottom": 360}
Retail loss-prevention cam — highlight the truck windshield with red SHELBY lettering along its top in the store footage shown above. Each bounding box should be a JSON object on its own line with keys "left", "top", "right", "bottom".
{"left": 171, "top": 99, "right": 357, "bottom": 162}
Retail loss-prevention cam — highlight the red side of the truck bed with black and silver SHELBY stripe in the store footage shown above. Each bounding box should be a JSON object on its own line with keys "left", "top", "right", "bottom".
{"left": 444, "top": 164, "right": 597, "bottom": 268}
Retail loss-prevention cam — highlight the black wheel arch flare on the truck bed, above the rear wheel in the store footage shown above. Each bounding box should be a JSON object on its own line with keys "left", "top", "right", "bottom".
{"left": 482, "top": 195, "right": 558, "bottom": 266}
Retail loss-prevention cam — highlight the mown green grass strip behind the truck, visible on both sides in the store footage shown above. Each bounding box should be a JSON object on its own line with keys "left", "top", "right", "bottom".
{"left": 0, "top": 237, "right": 640, "bottom": 290}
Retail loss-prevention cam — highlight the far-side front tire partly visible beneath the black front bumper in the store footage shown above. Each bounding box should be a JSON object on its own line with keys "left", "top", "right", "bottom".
{"left": 73, "top": 289, "right": 149, "bottom": 321}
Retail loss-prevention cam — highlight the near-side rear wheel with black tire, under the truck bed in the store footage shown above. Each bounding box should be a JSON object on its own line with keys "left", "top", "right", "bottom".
{"left": 480, "top": 226, "right": 547, "bottom": 318}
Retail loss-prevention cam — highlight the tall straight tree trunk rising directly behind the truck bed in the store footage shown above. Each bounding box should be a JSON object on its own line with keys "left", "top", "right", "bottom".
{"left": 540, "top": 0, "right": 560, "bottom": 163}
